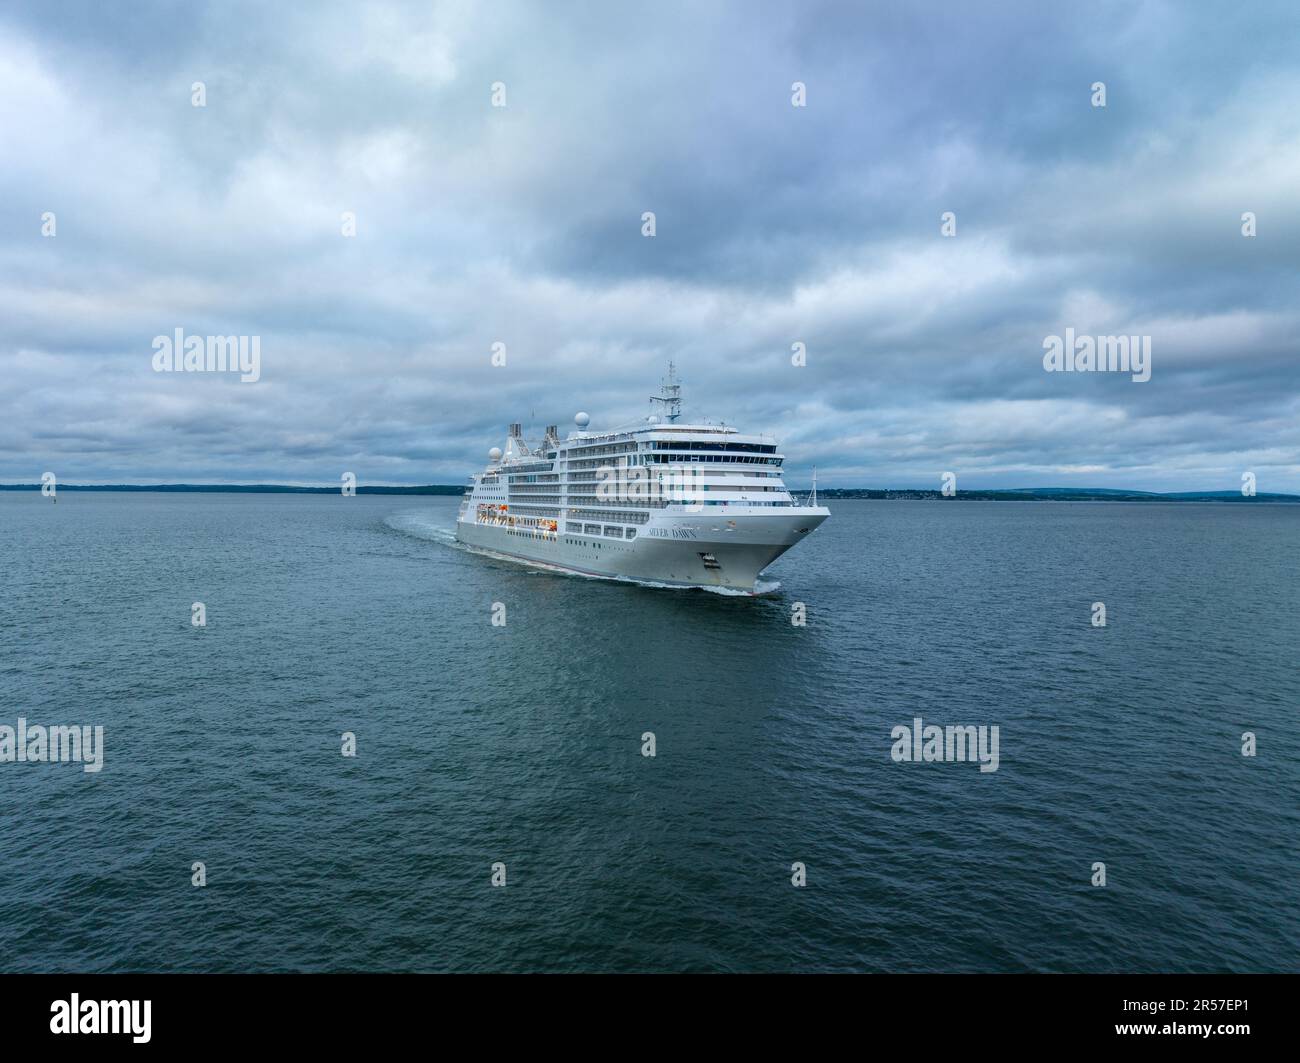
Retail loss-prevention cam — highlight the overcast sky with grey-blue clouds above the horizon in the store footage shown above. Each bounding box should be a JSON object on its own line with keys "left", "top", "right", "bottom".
{"left": 0, "top": 0, "right": 1300, "bottom": 493}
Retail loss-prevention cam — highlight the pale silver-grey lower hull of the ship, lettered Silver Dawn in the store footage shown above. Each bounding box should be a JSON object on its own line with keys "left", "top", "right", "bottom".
{"left": 456, "top": 506, "right": 829, "bottom": 591}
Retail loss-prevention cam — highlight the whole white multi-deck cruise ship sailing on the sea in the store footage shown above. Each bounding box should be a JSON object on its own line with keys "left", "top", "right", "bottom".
{"left": 456, "top": 364, "right": 831, "bottom": 593}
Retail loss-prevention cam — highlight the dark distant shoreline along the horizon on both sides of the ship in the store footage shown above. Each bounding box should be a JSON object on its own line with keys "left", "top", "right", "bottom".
{"left": 0, "top": 483, "right": 1300, "bottom": 503}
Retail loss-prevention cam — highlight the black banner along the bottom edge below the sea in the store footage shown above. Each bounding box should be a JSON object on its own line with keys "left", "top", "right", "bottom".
{"left": 0, "top": 975, "right": 1279, "bottom": 1058}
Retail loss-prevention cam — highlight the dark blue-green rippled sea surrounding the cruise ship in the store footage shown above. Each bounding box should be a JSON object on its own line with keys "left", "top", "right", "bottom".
{"left": 0, "top": 491, "right": 1300, "bottom": 971}
